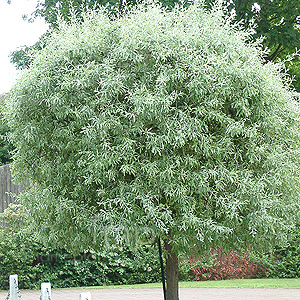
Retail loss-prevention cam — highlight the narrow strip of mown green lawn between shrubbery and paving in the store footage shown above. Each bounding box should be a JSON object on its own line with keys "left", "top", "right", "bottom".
{"left": 77, "top": 278, "right": 300, "bottom": 289}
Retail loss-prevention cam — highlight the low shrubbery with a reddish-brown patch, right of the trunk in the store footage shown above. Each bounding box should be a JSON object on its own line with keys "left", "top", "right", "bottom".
{"left": 189, "top": 225, "right": 300, "bottom": 280}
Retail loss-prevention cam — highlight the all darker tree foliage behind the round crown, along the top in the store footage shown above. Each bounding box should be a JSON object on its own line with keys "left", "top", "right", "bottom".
{"left": 11, "top": 0, "right": 300, "bottom": 91}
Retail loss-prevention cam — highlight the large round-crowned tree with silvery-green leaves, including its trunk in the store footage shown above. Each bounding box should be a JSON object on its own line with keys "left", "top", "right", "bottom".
{"left": 6, "top": 2, "right": 300, "bottom": 300}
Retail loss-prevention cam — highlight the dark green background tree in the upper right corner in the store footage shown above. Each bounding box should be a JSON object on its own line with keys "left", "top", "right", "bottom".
{"left": 205, "top": 0, "right": 300, "bottom": 92}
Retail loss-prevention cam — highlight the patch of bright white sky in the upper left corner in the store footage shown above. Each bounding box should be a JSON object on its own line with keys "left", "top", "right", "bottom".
{"left": 0, "top": 0, "right": 48, "bottom": 94}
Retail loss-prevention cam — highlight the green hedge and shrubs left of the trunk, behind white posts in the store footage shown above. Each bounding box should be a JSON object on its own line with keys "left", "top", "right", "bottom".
{"left": 0, "top": 204, "right": 160, "bottom": 289}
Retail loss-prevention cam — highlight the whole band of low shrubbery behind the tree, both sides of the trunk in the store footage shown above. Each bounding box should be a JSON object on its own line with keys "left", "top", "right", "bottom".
{"left": 0, "top": 204, "right": 300, "bottom": 290}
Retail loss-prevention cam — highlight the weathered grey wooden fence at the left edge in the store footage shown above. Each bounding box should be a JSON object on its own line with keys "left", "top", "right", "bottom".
{"left": 0, "top": 165, "right": 24, "bottom": 213}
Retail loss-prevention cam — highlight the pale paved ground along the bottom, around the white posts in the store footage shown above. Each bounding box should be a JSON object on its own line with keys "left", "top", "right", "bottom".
{"left": 0, "top": 288, "right": 300, "bottom": 300}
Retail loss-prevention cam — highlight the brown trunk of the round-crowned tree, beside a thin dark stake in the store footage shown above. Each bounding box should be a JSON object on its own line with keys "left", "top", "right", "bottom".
{"left": 165, "top": 240, "right": 179, "bottom": 300}
